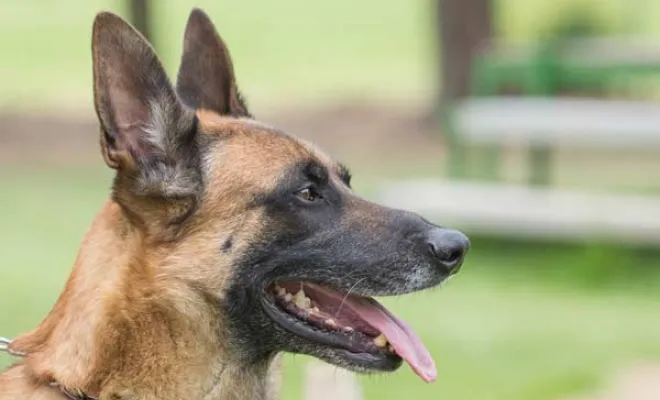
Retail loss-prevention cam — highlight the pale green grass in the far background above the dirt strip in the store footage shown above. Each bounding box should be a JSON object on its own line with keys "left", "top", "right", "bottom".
{"left": 6, "top": 0, "right": 660, "bottom": 110}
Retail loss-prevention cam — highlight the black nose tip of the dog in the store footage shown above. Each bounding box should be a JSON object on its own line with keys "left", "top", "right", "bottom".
{"left": 428, "top": 228, "right": 470, "bottom": 274}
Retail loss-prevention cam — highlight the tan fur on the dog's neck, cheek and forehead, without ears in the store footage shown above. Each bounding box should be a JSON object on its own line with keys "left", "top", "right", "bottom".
{"left": 0, "top": 107, "right": 334, "bottom": 400}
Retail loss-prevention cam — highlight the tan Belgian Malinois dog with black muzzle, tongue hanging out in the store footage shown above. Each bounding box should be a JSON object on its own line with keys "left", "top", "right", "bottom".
{"left": 0, "top": 9, "right": 469, "bottom": 400}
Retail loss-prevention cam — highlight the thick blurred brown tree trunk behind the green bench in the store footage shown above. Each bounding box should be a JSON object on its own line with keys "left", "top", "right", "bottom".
{"left": 435, "top": 0, "right": 493, "bottom": 110}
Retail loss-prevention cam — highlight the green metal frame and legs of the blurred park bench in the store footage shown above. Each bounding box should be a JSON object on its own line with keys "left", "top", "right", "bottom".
{"left": 441, "top": 38, "right": 660, "bottom": 185}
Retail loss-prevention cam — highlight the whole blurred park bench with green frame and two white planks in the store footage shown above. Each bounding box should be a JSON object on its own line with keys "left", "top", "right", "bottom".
{"left": 378, "top": 39, "right": 660, "bottom": 246}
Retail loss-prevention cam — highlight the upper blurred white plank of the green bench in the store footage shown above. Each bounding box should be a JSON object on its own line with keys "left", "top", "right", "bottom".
{"left": 453, "top": 97, "right": 660, "bottom": 148}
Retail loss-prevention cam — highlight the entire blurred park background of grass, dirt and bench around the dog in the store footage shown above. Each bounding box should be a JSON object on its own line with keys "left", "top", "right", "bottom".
{"left": 0, "top": 0, "right": 660, "bottom": 400}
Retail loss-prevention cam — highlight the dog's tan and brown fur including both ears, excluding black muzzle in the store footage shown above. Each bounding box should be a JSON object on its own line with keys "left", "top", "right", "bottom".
{"left": 0, "top": 10, "right": 410, "bottom": 400}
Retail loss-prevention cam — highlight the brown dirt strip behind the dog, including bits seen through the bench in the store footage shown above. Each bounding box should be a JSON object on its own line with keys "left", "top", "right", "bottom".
{"left": 0, "top": 101, "right": 660, "bottom": 193}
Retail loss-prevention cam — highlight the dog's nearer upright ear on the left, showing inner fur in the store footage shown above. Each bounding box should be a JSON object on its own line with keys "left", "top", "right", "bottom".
{"left": 92, "top": 12, "right": 196, "bottom": 200}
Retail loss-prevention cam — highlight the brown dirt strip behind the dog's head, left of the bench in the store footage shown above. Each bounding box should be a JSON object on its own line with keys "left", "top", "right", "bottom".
{"left": 0, "top": 104, "right": 444, "bottom": 173}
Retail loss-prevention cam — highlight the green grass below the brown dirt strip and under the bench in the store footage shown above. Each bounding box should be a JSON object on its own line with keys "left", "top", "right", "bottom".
{"left": 0, "top": 166, "right": 660, "bottom": 400}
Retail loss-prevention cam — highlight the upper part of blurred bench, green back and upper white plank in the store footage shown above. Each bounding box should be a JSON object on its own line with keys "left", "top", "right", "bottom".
{"left": 443, "top": 37, "right": 660, "bottom": 185}
